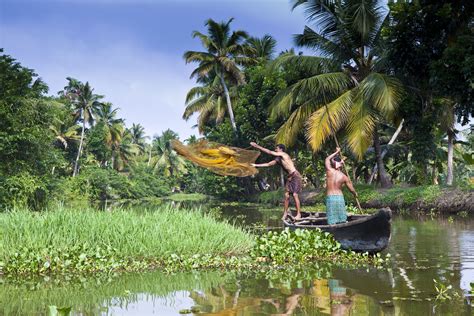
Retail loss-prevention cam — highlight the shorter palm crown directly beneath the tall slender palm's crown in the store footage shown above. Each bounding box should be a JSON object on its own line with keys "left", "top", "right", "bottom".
{"left": 183, "top": 77, "right": 237, "bottom": 134}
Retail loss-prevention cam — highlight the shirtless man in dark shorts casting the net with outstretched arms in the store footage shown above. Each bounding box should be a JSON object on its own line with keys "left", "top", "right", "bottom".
{"left": 250, "top": 142, "right": 303, "bottom": 220}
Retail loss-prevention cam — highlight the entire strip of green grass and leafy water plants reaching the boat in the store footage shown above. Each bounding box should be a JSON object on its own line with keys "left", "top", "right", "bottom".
{"left": 0, "top": 206, "right": 385, "bottom": 276}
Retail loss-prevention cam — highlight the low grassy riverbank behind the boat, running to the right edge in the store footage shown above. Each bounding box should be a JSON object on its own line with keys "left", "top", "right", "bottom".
{"left": 257, "top": 185, "right": 474, "bottom": 214}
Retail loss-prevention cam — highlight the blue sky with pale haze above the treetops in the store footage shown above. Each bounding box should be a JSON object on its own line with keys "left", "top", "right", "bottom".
{"left": 0, "top": 0, "right": 305, "bottom": 139}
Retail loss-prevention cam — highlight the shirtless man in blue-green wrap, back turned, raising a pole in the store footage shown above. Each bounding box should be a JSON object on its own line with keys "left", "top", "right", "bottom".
{"left": 325, "top": 147, "right": 357, "bottom": 225}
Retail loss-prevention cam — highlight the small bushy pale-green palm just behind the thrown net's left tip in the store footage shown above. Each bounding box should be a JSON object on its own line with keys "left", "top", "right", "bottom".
{"left": 152, "top": 129, "right": 186, "bottom": 177}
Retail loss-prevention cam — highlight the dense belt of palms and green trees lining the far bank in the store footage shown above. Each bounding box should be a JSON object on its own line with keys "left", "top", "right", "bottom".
{"left": 0, "top": 0, "right": 474, "bottom": 210}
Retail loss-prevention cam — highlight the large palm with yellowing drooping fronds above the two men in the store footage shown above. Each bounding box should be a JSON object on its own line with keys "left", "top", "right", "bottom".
{"left": 271, "top": 0, "right": 402, "bottom": 187}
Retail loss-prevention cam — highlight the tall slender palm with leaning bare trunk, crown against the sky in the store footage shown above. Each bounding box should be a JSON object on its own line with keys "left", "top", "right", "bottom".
{"left": 184, "top": 19, "right": 254, "bottom": 133}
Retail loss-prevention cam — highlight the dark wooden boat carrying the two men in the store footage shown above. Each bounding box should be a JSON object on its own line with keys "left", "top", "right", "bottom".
{"left": 283, "top": 208, "right": 392, "bottom": 253}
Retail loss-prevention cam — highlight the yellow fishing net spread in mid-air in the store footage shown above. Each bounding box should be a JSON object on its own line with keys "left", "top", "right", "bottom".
{"left": 171, "top": 140, "right": 260, "bottom": 177}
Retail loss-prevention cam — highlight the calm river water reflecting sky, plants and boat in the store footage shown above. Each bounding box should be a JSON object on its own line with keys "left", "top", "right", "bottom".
{"left": 0, "top": 205, "right": 474, "bottom": 315}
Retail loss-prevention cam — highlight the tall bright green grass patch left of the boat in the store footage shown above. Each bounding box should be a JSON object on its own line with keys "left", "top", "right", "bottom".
{"left": 0, "top": 206, "right": 253, "bottom": 262}
